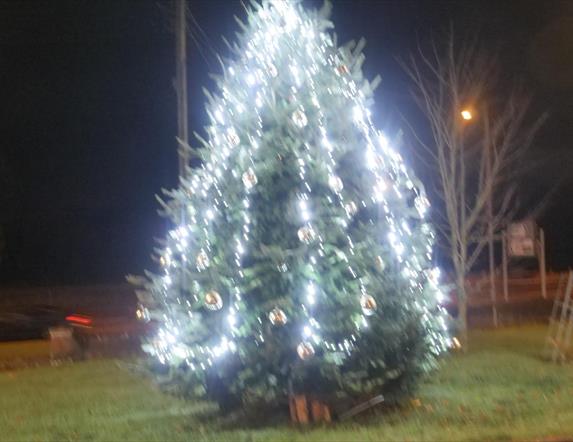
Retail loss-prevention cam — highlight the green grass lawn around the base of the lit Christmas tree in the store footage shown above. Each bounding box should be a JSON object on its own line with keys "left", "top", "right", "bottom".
{"left": 0, "top": 327, "right": 573, "bottom": 441}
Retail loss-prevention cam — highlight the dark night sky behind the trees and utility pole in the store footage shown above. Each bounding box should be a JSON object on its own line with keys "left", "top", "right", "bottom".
{"left": 0, "top": 0, "right": 573, "bottom": 284}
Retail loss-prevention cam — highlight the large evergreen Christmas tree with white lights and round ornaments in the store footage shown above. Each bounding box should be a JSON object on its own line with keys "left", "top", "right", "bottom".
{"left": 133, "top": 1, "right": 448, "bottom": 412}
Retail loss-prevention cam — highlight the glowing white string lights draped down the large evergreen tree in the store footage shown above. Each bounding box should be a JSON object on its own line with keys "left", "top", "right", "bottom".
{"left": 141, "top": 0, "right": 447, "bottom": 370}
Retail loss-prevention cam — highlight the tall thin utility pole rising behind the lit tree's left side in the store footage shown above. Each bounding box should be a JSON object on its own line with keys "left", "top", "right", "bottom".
{"left": 175, "top": 0, "right": 189, "bottom": 178}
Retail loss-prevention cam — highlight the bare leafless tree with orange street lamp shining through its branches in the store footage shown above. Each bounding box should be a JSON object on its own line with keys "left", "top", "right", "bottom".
{"left": 403, "top": 33, "right": 545, "bottom": 345}
